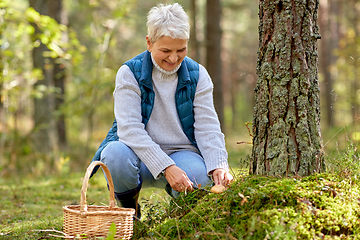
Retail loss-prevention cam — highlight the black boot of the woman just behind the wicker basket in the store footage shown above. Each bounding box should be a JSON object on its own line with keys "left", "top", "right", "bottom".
{"left": 115, "top": 178, "right": 142, "bottom": 220}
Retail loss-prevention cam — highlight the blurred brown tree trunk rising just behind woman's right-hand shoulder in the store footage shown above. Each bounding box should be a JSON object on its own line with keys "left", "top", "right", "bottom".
{"left": 206, "top": 0, "right": 225, "bottom": 130}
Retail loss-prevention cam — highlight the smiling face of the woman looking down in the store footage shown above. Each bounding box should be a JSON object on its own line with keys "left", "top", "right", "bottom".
{"left": 146, "top": 36, "right": 188, "bottom": 71}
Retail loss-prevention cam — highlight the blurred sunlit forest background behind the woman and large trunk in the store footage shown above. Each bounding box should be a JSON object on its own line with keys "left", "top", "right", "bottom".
{"left": 0, "top": 0, "right": 360, "bottom": 177}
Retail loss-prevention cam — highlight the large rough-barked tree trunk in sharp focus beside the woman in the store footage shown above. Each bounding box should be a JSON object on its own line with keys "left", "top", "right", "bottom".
{"left": 250, "top": 0, "right": 325, "bottom": 176}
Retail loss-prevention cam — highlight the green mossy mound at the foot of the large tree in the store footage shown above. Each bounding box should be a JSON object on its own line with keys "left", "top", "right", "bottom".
{"left": 134, "top": 173, "right": 360, "bottom": 239}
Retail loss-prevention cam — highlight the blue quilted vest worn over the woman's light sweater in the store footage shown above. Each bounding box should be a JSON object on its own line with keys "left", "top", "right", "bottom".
{"left": 91, "top": 51, "right": 199, "bottom": 176}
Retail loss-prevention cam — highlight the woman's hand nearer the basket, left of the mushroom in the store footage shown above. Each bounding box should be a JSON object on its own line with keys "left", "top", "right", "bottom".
{"left": 164, "top": 165, "right": 193, "bottom": 192}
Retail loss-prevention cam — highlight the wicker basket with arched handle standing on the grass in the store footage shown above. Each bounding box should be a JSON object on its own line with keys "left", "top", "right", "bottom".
{"left": 63, "top": 161, "right": 135, "bottom": 239}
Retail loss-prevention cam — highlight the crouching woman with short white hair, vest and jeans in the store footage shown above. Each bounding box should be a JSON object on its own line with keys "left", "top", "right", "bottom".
{"left": 93, "top": 3, "right": 232, "bottom": 217}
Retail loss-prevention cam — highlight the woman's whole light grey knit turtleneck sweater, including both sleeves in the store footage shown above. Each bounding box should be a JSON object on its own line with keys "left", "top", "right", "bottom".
{"left": 114, "top": 55, "right": 229, "bottom": 179}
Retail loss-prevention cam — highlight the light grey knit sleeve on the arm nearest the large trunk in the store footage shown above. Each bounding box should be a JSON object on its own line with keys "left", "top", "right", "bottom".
{"left": 194, "top": 65, "right": 229, "bottom": 173}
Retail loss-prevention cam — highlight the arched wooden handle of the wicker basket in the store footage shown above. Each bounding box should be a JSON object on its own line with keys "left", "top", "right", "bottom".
{"left": 80, "top": 161, "right": 115, "bottom": 213}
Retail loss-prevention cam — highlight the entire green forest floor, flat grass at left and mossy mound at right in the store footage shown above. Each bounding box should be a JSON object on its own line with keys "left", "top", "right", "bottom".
{"left": 0, "top": 140, "right": 360, "bottom": 239}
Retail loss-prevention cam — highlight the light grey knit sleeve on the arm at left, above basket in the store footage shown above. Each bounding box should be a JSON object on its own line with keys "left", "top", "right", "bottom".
{"left": 113, "top": 65, "right": 175, "bottom": 179}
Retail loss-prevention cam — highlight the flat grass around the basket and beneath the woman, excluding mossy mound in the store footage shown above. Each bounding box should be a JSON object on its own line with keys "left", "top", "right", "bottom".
{"left": 0, "top": 172, "right": 169, "bottom": 240}
